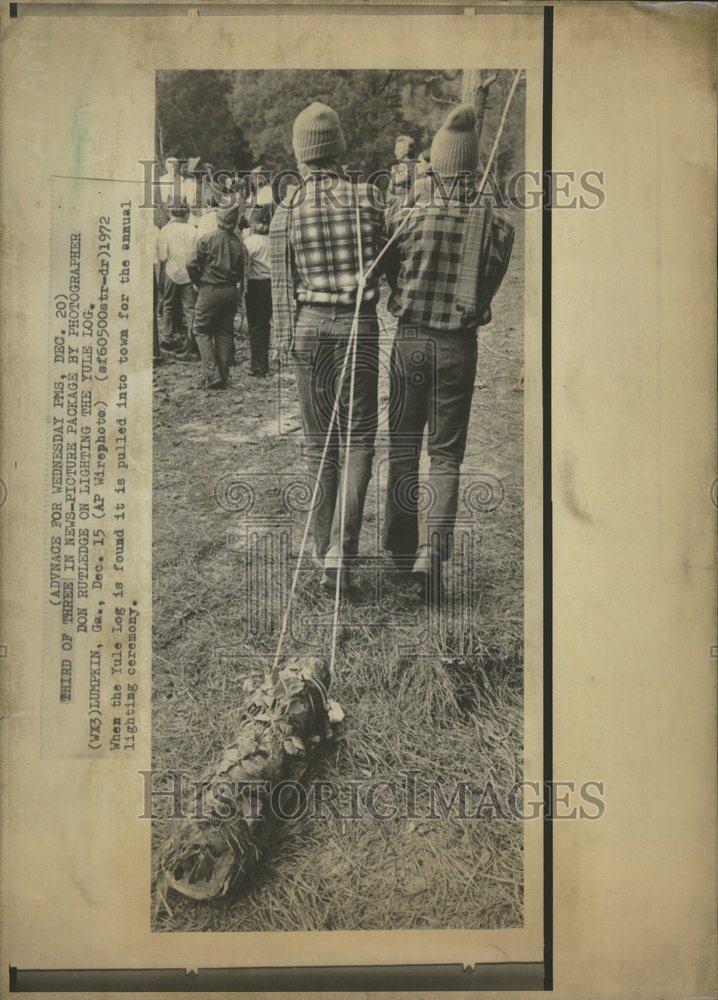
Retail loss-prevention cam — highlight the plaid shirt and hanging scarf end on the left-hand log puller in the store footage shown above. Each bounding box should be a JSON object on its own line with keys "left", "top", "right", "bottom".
{"left": 269, "top": 171, "right": 386, "bottom": 344}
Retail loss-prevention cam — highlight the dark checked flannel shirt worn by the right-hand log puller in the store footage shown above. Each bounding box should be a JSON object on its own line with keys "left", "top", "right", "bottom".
{"left": 385, "top": 182, "right": 513, "bottom": 331}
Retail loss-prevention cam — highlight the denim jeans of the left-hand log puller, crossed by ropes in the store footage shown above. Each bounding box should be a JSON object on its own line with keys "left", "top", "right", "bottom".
{"left": 293, "top": 305, "right": 379, "bottom": 568}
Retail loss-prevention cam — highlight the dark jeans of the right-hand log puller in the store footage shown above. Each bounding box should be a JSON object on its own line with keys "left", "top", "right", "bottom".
{"left": 383, "top": 324, "right": 477, "bottom": 559}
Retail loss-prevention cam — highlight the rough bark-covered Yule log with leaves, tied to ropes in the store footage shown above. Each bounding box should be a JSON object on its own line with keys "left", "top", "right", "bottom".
{"left": 159, "top": 657, "right": 332, "bottom": 900}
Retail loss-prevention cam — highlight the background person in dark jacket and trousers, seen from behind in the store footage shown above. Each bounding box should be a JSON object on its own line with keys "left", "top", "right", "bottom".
{"left": 187, "top": 206, "right": 247, "bottom": 389}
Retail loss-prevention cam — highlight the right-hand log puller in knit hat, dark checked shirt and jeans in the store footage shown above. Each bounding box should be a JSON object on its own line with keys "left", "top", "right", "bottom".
{"left": 384, "top": 106, "right": 513, "bottom": 604}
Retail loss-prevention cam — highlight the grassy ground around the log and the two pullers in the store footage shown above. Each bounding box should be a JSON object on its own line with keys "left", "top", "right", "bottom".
{"left": 153, "top": 209, "right": 524, "bottom": 931}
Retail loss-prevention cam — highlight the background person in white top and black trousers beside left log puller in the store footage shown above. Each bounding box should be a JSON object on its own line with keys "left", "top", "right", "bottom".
{"left": 245, "top": 197, "right": 272, "bottom": 377}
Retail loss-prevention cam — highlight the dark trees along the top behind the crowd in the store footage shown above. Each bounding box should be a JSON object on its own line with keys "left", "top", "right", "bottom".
{"left": 155, "top": 70, "right": 526, "bottom": 183}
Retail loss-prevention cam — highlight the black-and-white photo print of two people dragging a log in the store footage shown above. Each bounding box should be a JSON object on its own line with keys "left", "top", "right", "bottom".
{"left": 146, "top": 67, "right": 530, "bottom": 932}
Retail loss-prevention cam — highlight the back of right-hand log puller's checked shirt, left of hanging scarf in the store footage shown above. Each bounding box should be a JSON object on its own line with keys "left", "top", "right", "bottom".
{"left": 385, "top": 189, "right": 496, "bottom": 330}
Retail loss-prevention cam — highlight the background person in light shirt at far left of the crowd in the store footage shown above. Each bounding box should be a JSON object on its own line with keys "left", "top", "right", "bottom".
{"left": 157, "top": 204, "right": 197, "bottom": 353}
